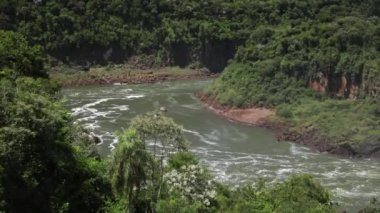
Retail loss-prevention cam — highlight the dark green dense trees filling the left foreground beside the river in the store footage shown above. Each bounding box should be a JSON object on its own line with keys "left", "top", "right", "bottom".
{"left": 0, "top": 77, "right": 110, "bottom": 212}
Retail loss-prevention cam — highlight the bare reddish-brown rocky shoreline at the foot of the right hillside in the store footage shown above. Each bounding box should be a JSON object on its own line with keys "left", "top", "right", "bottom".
{"left": 195, "top": 92, "right": 380, "bottom": 159}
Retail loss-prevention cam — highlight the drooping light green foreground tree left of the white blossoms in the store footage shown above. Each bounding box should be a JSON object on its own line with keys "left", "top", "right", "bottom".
{"left": 110, "top": 113, "right": 187, "bottom": 211}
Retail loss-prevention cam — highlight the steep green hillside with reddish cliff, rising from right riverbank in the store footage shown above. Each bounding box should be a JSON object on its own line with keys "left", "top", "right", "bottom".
{"left": 205, "top": 1, "right": 380, "bottom": 156}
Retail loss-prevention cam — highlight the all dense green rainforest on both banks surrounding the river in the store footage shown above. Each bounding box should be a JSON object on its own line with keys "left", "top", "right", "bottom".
{"left": 0, "top": 0, "right": 380, "bottom": 212}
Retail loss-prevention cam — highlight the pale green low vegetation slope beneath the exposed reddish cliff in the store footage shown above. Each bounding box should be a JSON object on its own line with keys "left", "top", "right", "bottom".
{"left": 276, "top": 98, "right": 380, "bottom": 149}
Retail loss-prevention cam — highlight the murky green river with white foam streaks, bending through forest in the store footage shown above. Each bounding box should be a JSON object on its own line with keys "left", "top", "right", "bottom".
{"left": 63, "top": 81, "right": 380, "bottom": 212}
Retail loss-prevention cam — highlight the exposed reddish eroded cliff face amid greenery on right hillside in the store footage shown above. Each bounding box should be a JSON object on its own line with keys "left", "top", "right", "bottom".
{"left": 308, "top": 73, "right": 380, "bottom": 99}
